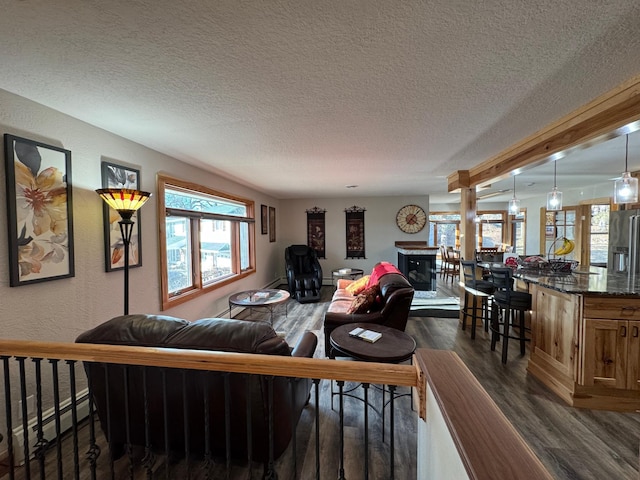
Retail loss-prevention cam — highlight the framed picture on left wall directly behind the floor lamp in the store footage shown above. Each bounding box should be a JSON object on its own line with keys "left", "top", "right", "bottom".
{"left": 102, "top": 162, "right": 142, "bottom": 272}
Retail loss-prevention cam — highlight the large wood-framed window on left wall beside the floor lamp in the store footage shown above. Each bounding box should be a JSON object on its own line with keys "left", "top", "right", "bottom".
{"left": 158, "top": 175, "right": 255, "bottom": 309}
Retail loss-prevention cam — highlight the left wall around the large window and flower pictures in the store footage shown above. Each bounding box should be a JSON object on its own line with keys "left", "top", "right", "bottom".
{"left": 0, "top": 90, "right": 284, "bottom": 341}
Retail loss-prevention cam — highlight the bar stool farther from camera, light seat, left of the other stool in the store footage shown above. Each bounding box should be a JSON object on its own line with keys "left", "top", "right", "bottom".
{"left": 460, "top": 260, "right": 495, "bottom": 340}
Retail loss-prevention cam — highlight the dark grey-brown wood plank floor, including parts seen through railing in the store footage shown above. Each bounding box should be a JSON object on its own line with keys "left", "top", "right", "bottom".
{"left": 6, "top": 282, "right": 640, "bottom": 480}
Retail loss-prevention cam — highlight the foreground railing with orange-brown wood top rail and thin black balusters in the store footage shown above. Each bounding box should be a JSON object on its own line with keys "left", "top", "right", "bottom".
{"left": 0, "top": 340, "right": 418, "bottom": 478}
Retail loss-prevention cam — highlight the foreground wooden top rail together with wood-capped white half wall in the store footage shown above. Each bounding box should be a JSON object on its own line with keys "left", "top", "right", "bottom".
{"left": 0, "top": 340, "right": 551, "bottom": 480}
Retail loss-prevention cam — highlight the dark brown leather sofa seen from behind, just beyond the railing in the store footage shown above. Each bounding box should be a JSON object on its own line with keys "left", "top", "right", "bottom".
{"left": 76, "top": 315, "right": 317, "bottom": 463}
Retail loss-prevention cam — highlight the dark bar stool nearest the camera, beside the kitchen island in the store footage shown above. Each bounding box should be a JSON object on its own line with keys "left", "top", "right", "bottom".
{"left": 490, "top": 267, "right": 531, "bottom": 363}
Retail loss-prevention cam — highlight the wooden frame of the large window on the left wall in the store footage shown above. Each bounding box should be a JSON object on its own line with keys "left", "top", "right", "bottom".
{"left": 157, "top": 174, "right": 256, "bottom": 310}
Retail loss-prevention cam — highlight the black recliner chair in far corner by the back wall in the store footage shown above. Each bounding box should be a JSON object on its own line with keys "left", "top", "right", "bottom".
{"left": 284, "top": 245, "right": 322, "bottom": 303}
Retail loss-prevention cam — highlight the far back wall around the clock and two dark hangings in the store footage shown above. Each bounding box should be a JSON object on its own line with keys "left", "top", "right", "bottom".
{"left": 278, "top": 195, "right": 429, "bottom": 283}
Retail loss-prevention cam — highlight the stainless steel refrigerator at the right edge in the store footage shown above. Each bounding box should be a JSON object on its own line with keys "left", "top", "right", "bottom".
{"left": 608, "top": 210, "right": 640, "bottom": 275}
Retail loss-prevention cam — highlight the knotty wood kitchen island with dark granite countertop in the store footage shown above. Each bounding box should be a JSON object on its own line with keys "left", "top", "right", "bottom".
{"left": 517, "top": 267, "right": 640, "bottom": 411}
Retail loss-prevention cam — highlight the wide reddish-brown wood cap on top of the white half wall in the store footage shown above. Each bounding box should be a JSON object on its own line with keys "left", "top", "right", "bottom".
{"left": 414, "top": 348, "right": 552, "bottom": 480}
